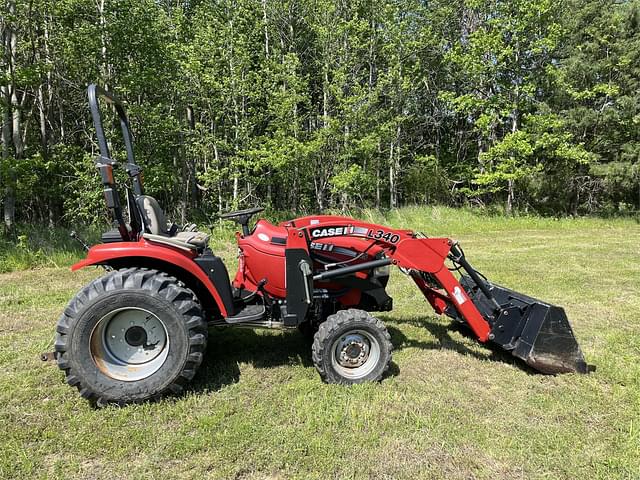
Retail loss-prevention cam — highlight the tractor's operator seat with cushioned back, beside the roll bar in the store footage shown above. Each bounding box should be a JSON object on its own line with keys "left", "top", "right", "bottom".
{"left": 136, "top": 195, "right": 209, "bottom": 250}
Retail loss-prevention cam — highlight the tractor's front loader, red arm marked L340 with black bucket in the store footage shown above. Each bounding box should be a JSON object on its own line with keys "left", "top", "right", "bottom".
{"left": 285, "top": 216, "right": 591, "bottom": 374}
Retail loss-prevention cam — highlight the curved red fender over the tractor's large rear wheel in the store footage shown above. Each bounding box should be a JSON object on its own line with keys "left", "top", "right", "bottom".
{"left": 71, "top": 239, "right": 233, "bottom": 317}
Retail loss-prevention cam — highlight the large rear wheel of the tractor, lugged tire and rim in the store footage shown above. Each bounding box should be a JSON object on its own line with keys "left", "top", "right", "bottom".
{"left": 55, "top": 268, "right": 207, "bottom": 406}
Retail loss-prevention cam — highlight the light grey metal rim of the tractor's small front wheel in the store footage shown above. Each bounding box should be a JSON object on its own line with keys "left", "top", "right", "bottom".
{"left": 331, "top": 330, "right": 380, "bottom": 380}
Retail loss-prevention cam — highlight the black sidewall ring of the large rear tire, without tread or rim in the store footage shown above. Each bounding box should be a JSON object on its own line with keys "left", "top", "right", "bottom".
{"left": 68, "top": 289, "right": 189, "bottom": 402}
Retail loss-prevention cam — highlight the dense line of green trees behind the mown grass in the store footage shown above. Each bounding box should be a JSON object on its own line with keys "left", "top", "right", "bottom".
{"left": 0, "top": 0, "right": 640, "bottom": 229}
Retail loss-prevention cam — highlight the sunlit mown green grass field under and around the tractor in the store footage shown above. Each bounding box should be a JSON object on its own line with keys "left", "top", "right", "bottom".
{"left": 0, "top": 208, "right": 640, "bottom": 480}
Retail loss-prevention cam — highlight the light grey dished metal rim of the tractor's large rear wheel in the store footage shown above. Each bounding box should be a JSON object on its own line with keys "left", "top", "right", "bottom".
{"left": 91, "top": 307, "right": 169, "bottom": 382}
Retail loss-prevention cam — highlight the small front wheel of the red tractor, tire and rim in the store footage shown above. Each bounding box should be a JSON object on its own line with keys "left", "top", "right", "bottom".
{"left": 312, "top": 309, "right": 393, "bottom": 385}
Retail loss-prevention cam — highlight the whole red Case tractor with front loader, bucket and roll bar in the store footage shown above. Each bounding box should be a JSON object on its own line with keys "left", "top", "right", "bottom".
{"left": 54, "top": 85, "right": 589, "bottom": 405}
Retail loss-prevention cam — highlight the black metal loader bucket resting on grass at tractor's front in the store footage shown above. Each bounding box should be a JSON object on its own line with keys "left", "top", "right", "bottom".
{"left": 460, "top": 276, "right": 590, "bottom": 374}
